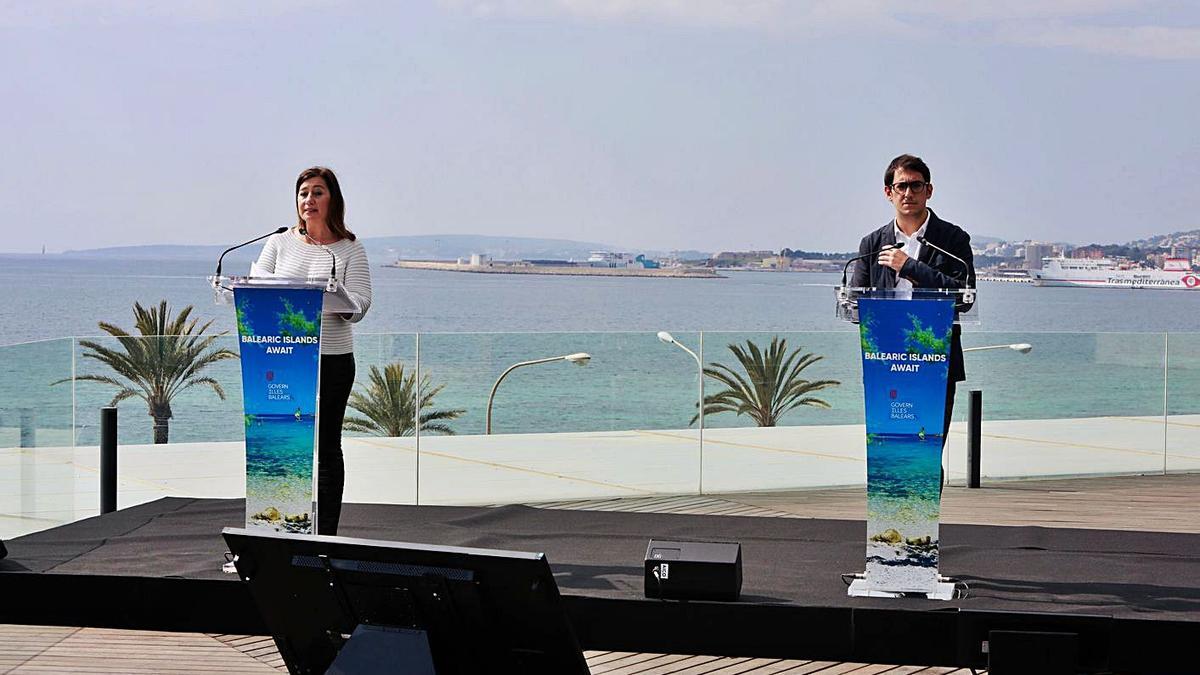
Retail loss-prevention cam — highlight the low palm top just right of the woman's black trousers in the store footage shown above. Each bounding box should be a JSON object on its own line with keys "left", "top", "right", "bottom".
{"left": 342, "top": 362, "right": 467, "bottom": 436}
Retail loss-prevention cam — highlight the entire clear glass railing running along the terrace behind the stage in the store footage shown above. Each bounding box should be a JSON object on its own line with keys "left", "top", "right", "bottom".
{"left": 0, "top": 330, "right": 1200, "bottom": 538}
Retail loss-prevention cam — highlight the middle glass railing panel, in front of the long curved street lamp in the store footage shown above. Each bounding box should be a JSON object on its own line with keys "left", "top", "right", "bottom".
{"left": 419, "top": 333, "right": 700, "bottom": 503}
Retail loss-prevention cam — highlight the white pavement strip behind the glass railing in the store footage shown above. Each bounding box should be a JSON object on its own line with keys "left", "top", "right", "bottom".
{"left": 0, "top": 416, "right": 1200, "bottom": 539}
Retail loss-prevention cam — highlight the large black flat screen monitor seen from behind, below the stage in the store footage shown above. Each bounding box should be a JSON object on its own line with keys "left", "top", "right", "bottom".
{"left": 222, "top": 528, "right": 588, "bottom": 675}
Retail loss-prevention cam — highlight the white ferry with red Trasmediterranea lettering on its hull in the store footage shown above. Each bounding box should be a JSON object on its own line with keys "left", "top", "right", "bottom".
{"left": 1030, "top": 258, "right": 1200, "bottom": 291}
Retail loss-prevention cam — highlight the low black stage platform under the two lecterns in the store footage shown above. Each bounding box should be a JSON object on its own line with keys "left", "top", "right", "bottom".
{"left": 0, "top": 498, "right": 1200, "bottom": 674}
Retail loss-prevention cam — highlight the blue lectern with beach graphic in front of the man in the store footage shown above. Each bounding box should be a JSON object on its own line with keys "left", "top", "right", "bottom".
{"left": 838, "top": 281, "right": 977, "bottom": 599}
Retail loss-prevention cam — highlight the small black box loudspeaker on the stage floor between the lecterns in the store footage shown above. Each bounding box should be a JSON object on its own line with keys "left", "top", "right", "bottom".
{"left": 646, "top": 539, "right": 742, "bottom": 601}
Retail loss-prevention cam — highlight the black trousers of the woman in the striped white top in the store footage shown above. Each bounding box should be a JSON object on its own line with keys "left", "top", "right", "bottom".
{"left": 317, "top": 354, "right": 354, "bottom": 534}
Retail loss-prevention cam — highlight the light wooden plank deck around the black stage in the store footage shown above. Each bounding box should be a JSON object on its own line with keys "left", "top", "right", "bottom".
{"left": 0, "top": 474, "right": 1200, "bottom": 675}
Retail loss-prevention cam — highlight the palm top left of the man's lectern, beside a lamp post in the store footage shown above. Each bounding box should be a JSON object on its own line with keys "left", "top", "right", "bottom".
{"left": 691, "top": 335, "right": 841, "bottom": 426}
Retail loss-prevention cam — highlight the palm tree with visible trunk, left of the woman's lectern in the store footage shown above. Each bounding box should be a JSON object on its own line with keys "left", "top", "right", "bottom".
{"left": 66, "top": 300, "right": 238, "bottom": 443}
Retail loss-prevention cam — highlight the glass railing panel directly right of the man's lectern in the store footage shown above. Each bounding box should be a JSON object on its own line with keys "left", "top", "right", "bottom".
{"left": 948, "top": 333, "right": 1165, "bottom": 483}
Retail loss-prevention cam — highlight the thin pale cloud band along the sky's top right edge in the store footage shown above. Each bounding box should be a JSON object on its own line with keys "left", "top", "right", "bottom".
{"left": 439, "top": 0, "right": 1200, "bottom": 59}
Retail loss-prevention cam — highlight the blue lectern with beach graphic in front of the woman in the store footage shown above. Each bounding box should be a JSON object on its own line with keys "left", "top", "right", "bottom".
{"left": 210, "top": 271, "right": 360, "bottom": 533}
